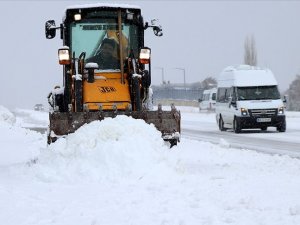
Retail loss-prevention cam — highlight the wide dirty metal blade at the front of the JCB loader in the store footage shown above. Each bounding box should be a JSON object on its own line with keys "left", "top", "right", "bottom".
{"left": 48, "top": 106, "right": 181, "bottom": 147}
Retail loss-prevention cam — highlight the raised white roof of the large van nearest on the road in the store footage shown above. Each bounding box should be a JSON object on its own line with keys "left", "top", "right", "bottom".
{"left": 218, "top": 65, "right": 277, "bottom": 87}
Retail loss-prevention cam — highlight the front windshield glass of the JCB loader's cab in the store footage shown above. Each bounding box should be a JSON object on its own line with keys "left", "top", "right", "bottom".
{"left": 70, "top": 18, "right": 139, "bottom": 69}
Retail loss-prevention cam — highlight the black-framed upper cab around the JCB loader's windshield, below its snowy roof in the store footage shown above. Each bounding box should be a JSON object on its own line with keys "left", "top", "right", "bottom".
{"left": 63, "top": 7, "right": 144, "bottom": 69}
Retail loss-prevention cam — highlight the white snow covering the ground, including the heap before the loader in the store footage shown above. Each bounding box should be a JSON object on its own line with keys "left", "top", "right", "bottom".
{"left": 0, "top": 107, "right": 300, "bottom": 225}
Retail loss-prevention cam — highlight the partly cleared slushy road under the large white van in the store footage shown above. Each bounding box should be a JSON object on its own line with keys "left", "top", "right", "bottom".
{"left": 182, "top": 113, "right": 300, "bottom": 158}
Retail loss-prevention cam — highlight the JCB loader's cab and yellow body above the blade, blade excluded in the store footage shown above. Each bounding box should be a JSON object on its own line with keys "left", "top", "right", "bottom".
{"left": 45, "top": 3, "right": 162, "bottom": 112}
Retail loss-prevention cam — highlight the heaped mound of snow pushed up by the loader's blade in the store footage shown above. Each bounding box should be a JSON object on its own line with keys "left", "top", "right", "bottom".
{"left": 33, "top": 116, "right": 170, "bottom": 182}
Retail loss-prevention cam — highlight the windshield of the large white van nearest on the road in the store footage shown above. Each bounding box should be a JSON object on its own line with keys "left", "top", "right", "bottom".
{"left": 236, "top": 85, "right": 280, "bottom": 100}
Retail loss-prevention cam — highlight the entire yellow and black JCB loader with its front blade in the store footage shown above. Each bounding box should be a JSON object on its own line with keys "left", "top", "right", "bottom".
{"left": 45, "top": 4, "right": 181, "bottom": 147}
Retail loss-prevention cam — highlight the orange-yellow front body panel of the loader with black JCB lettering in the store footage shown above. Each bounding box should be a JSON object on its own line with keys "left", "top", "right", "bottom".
{"left": 83, "top": 72, "right": 131, "bottom": 111}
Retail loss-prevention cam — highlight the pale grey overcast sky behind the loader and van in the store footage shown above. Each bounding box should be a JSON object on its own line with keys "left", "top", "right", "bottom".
{"left": 0, "top": 1, "right": 300, "bottom": 108}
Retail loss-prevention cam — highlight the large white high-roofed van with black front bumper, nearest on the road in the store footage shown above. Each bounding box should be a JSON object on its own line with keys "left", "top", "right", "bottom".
{"left": 216, "top": 65, "right": 286, "bottom": 133}
